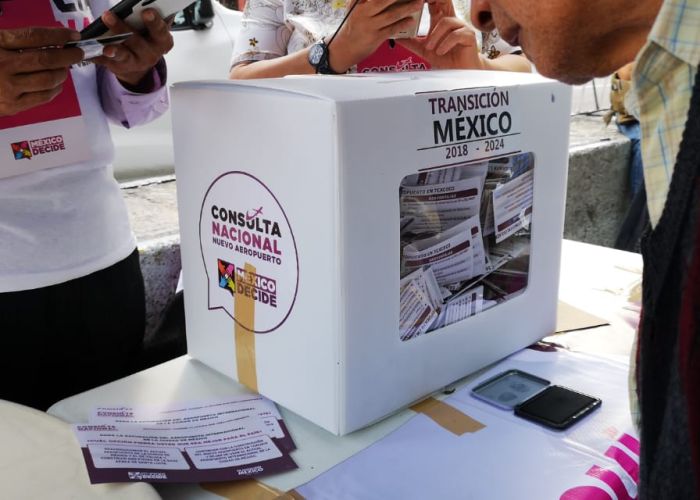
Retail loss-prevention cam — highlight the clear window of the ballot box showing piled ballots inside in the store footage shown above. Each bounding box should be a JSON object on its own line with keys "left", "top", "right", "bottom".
{"left": 399, "top": 153, "right": 535, "bottom": 341}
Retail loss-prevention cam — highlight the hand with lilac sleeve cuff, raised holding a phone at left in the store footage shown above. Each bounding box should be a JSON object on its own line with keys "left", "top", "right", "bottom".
{"left": 94, "top": 9, "right": 173, "bottom": 128}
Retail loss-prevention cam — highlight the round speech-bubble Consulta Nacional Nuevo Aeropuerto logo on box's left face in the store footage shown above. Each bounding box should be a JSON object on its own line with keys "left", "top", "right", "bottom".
{"left": 199, "top": 172, "right": 299, "bottom": 333}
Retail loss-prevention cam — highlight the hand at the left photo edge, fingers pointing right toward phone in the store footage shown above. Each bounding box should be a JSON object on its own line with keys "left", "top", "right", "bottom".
{"left": 0, "top": 28, "right": 83, "bottom": 116}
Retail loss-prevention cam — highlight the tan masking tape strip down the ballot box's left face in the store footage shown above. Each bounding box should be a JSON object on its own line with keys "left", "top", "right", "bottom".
{"left": 233, "top": 263, "right": 258, "bottom": 392}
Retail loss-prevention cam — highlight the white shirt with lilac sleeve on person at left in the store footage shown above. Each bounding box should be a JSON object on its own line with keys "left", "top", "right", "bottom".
{"left": 0, "top": 0, "right": 168, "bottom": 293}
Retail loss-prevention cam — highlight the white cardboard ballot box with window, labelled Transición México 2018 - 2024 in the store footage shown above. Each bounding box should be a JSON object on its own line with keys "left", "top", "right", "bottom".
{"left": 173, "top": 71, "right": 570, "bottom": 434}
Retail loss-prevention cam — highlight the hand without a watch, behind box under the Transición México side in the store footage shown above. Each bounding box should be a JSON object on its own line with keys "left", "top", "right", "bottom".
{"left": 397, "top": 0, "right": 484, "bottom": 69}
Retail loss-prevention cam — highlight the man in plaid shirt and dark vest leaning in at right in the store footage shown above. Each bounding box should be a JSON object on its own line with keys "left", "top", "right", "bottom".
{"left": 472, "top": 0, "right": 700, "bottom": 500}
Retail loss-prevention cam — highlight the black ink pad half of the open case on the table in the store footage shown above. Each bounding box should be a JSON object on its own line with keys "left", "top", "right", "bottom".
{"left": 515, "top": 385, "right": 602, "bottom": 431}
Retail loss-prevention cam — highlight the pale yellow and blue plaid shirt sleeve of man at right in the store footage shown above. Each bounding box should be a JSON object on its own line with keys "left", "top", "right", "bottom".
{"left": 631, "top": 0, "right": 700, "bottom": 226}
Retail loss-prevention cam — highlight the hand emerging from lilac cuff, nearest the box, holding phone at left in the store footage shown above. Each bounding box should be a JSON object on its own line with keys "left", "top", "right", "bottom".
{"left": 93, "top": 9, "right": 173, "bottom": 90}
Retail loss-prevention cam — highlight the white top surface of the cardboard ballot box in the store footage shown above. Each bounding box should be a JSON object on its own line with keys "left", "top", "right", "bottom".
{"left": 174, "top": 70, "right": 552, "bottom": 102}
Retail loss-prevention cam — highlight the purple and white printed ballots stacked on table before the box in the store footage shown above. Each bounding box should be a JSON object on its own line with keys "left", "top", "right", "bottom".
{"left": 73, "top": 395, "right": 297, "bottom": 483}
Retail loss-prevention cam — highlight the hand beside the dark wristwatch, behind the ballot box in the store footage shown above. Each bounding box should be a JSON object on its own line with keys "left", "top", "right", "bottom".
{"left": 327, "top": 0, "right": 424, "bottom": 72}
